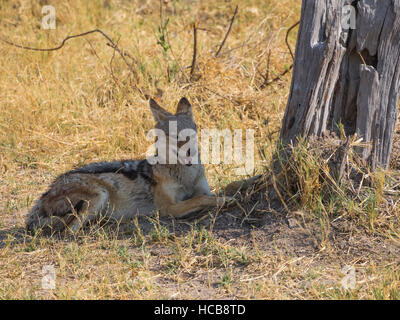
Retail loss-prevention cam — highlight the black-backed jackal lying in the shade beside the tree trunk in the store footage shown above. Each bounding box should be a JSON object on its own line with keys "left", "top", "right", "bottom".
{"left": 26, "top": 98, "right": 232, "bottom": 234}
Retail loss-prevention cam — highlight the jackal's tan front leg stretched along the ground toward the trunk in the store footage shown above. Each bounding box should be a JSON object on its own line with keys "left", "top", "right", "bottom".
{"left": 160, "top": 195, "right": 231, "bottom": 218}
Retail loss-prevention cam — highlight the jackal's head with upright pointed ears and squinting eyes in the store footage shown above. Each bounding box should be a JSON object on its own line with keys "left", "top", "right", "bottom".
{"left": 150, "top": 98, "right": 200, "bottom": 166}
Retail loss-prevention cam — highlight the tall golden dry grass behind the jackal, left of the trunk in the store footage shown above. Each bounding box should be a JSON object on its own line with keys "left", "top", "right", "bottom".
{"left": 0, "top": 1, "right": 299, "bottom": 209}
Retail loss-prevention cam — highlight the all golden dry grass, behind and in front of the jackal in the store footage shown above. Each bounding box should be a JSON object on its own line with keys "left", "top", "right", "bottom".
{"left": 0, "top": 0, "right": 400, "bottom": 299}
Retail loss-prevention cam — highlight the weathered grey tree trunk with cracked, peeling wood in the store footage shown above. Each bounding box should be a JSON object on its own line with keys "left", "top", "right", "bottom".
{"left": 281, "top": 0, "right": 400, "bottom": 167}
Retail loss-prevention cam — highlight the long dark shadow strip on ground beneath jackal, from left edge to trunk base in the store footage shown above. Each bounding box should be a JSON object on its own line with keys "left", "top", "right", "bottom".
{"left": 0, "top": 176, "right": 282, "bottom": 249}
